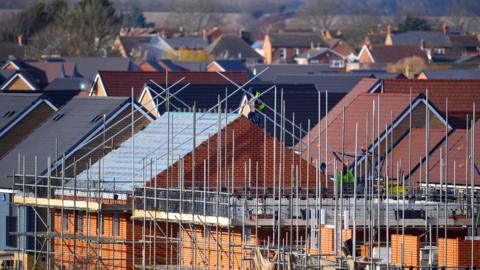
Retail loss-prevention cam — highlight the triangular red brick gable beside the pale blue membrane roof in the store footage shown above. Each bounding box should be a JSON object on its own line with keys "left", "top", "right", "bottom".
{"left": 152, "top": 116, "right": 325, "bottom": 192}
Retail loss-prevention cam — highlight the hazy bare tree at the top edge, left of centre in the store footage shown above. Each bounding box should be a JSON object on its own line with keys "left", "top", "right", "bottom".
{"left": 168, "top": 0, "right": 221, "bottom": 32}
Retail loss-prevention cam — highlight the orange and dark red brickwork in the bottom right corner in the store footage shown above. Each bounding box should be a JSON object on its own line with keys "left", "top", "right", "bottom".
{"left": 438, "top": 237, "right": 480, "bottom": 267}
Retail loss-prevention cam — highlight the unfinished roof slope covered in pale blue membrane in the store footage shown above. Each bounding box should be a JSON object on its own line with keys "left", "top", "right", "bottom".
{"left": 71, "top": 112, "right": 239, "bottom": 191}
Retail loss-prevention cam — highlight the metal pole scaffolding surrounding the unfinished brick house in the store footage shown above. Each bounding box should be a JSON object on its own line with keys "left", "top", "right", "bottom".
{"left": 12, "top": 71, "right": 480, "bottom": 269}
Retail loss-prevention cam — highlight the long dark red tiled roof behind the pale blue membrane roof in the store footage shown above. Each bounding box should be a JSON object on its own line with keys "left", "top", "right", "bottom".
{"left": 95, "top": 71, "right": 249, "bottom": 97}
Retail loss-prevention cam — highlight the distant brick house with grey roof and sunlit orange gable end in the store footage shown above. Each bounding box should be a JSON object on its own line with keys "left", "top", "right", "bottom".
{"left": 263, "top": 33, "right": 326, "bottom": 64}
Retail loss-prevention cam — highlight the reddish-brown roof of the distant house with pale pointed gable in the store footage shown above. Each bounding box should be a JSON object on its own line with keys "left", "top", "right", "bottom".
{"left": 365, "top": 45, "right": 427, "bottom": 63}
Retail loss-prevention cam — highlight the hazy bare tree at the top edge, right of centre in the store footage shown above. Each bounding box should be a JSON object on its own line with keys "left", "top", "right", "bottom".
{"left": 297, "top": 0, "right": 343, "bottom": 30}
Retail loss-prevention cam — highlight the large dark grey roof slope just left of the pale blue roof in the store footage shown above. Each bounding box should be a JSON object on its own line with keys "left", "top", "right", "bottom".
{"left": 0, "top": 97, "right": 130, "bottom": 188}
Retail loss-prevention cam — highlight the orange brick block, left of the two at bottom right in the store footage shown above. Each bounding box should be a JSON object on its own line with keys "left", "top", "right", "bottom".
{"left": 390, "top": 234, "right": 421, "bottom": 267}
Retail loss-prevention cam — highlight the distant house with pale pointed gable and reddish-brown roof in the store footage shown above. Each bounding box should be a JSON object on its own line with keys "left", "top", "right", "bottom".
{"left": 358, "top": 45, "right": 428, "bottom": 68}
